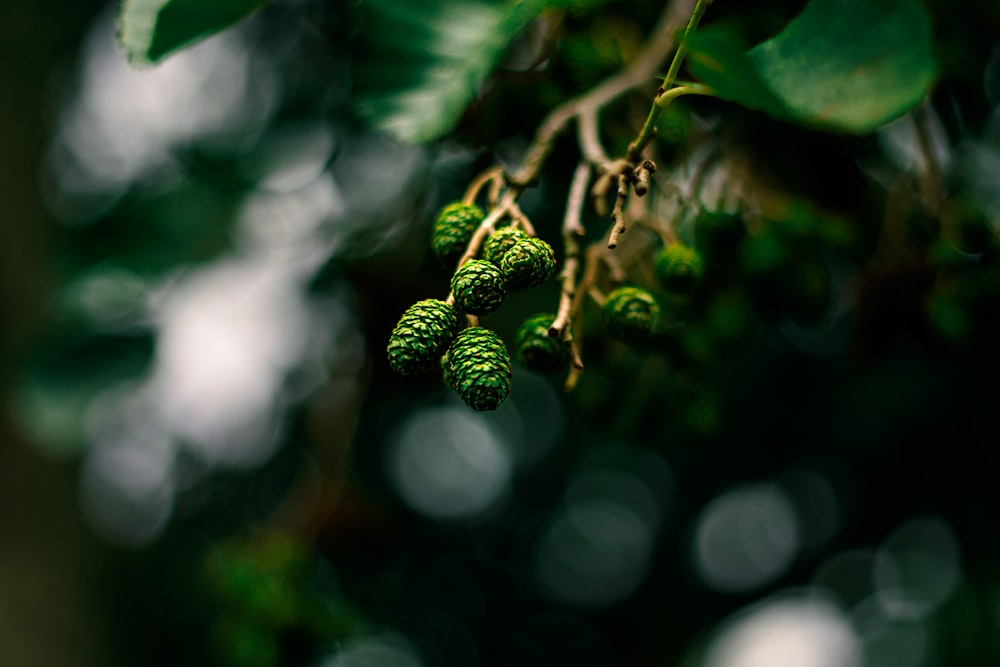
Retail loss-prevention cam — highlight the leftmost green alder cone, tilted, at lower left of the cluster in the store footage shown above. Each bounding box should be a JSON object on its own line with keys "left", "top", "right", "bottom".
{"left": 388, "top": 299, "right": 458, "bottom": 375}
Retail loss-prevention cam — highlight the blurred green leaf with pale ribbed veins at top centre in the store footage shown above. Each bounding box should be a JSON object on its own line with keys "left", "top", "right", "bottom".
{"left": 355, "top": 0, "right": 551, "bottom": 143}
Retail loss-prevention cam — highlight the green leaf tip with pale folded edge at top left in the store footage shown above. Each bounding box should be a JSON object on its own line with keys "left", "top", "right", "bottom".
{"left": 118, "top": 0, "right": 271, "bottom": 67}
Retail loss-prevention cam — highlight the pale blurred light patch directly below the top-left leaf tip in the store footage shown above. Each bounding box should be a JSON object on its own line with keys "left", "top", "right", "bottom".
{"left": 47, "top": 10, "right": 279, "bottom": 223}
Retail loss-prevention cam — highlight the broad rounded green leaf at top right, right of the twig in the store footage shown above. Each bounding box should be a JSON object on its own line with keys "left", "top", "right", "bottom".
{"left": 689, "top": 0, "right": 937, "bottom": 133}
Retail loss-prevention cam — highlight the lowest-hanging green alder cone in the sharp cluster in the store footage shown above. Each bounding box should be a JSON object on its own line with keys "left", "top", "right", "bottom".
{"left": 444, "top": 327, "right": 511, "bottom": 411}
